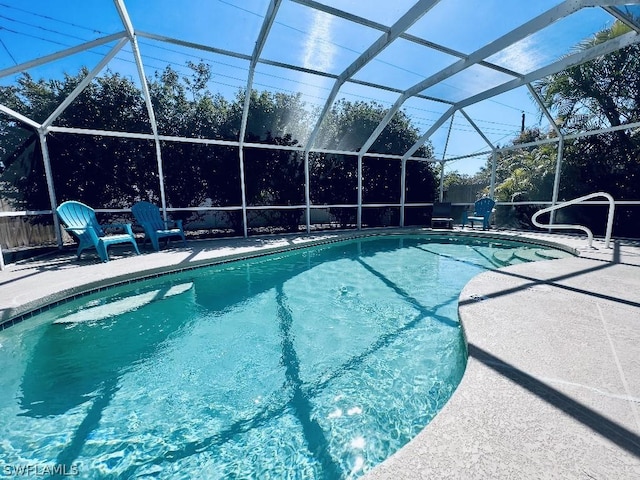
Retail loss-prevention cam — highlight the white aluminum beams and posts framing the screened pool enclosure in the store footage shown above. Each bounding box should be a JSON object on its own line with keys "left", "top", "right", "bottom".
{"left": 0, "top": 0, "right": 640, "bottom": 245}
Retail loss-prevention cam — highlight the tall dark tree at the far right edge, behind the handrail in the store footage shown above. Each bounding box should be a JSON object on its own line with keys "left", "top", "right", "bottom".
{"left": 534, "top": 22, "right": 640, "bottom": 236}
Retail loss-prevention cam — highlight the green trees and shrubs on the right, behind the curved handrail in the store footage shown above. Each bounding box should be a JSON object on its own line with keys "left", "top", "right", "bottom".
{"left": 452, "top": 22, "right": 640, "bottom": 236}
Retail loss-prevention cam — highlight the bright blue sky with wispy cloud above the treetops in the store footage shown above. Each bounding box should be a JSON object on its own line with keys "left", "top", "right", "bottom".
{"left": 0, "top": 0, "right": 613, "bottom": 174}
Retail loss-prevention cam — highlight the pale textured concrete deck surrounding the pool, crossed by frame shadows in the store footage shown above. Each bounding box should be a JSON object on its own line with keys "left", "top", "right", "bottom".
{"left": 0, "top": 229, "right": 640, "bottom": 480}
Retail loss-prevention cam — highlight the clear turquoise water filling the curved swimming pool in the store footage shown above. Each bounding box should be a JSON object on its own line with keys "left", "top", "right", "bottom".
{"left": 0, "top": 237, "right": 568, "bottom": 479}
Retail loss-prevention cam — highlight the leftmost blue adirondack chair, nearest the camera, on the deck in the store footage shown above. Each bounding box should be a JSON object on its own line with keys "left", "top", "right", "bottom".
{"left": 56, "top": 200, "right": 140, "bottom": 262}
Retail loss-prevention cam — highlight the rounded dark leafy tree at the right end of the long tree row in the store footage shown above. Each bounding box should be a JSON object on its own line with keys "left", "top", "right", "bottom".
{"left": 312, "top": 100, "right": 434, "bottom": 226}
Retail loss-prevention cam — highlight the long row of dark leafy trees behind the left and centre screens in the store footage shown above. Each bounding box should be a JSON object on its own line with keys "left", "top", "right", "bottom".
{"left": 0, "top": 62, "right": 434, "bottom": 235}
